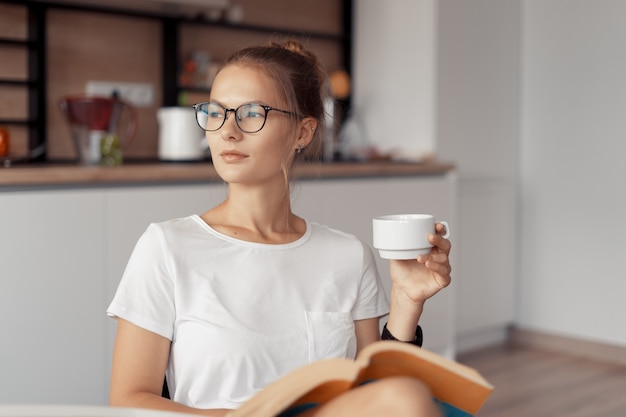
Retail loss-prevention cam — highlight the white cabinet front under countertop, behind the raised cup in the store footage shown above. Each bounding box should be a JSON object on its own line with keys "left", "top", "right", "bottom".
{"left": 292, "top": 173, "right": 456, "bottom": 357}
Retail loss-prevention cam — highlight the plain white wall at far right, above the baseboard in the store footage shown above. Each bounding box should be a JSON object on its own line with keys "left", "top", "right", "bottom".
{"left": 518, "top": 0, "right": 626, "bottom": 346}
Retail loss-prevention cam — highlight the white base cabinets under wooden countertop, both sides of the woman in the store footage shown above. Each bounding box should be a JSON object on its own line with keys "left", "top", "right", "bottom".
{"left": 0, "top": 173, "right": 456, "bottom": 405}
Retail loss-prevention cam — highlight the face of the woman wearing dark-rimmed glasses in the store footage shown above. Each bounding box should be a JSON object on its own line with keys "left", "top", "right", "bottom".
{"left": 206, "top": 65, "right": 296, "bottom": 184}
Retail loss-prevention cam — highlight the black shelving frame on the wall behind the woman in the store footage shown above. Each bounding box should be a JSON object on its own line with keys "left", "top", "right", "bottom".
{"left": 0, "top": 0, "right": 353, "bottom": 161}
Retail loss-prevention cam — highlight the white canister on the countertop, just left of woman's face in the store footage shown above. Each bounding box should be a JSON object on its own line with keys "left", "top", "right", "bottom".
{"left": 157, "top": 107, "right": 208, "bottom": 161}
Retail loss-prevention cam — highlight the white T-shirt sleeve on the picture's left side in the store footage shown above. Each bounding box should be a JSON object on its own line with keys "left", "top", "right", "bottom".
{"left": 107, "top": 224, "right": 176, "bottom": 340}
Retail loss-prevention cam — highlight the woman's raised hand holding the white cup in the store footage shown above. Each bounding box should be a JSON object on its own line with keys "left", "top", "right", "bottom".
{"left": 389, "top": 223, "right": 452, "bottom": 305}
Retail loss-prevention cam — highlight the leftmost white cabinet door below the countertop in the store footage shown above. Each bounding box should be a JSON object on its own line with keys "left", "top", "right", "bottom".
{"left": 0, "top": 190, "right": 108, "bottom": 404}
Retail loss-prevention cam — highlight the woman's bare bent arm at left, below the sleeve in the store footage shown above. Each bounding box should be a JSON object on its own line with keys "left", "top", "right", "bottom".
{"left": 109, "top": 319, "right": 228, "bottom": 417}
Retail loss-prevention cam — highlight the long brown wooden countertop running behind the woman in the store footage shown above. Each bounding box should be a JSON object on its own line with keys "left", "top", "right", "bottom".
{"left": 0, "top": 162, "right": 454, "bottom": 187}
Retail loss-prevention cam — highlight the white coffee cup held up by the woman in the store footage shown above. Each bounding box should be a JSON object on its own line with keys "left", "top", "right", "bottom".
{"left": 372, "top": 214, "right": 450, "bottom": 259}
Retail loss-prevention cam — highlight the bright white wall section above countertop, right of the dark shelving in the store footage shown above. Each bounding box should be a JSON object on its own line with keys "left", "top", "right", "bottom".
{"left": 352, "top": 0, "right": 436, "bottom": 157}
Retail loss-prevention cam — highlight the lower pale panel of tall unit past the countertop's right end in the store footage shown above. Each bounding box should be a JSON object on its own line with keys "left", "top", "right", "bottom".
{"left": 450, "top": 179, "right": 516, "bottom": 334}
